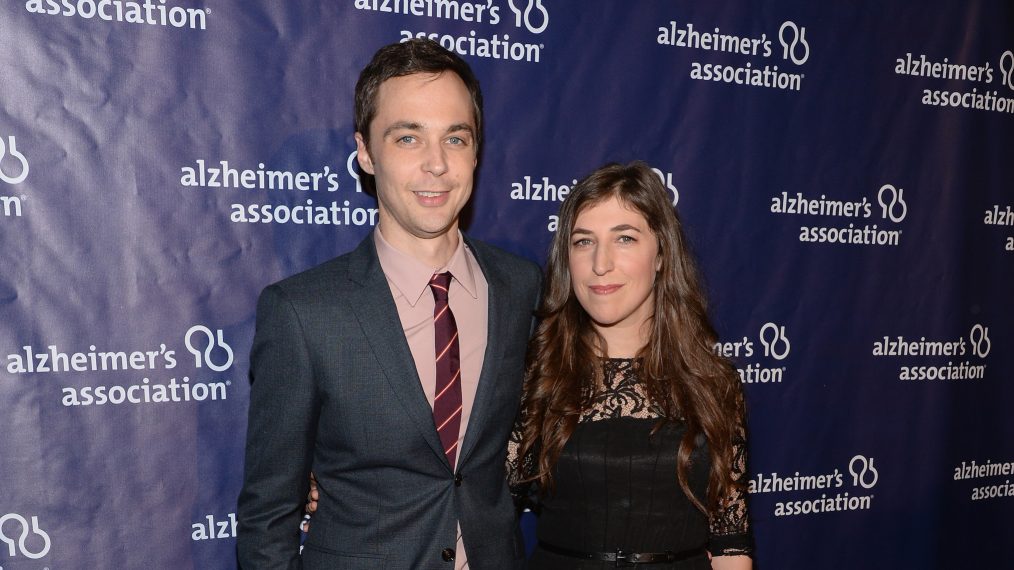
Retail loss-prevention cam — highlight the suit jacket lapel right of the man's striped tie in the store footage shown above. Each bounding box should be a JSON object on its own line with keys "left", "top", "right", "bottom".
{"left": 458, "top": 238, "right": 510, "bottom": 465}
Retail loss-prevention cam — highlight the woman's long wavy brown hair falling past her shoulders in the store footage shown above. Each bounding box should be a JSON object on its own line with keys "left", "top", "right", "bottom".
{"left": 520, "top": 161, "right": 744, "bottom": 513}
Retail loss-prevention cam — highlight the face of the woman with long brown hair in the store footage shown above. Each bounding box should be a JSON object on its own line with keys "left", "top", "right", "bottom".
{"left": 570, "top": 197, "right": 661, "bottom": 340}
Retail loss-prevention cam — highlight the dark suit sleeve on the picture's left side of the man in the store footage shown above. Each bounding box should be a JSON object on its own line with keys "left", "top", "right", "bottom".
{"left": 237, "top": 285, "right": 318, "bottom": 570}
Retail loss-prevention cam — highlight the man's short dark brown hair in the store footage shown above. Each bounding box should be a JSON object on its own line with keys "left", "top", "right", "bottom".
{"left": 355, "top": 39, "right": 483, "bottom": 152}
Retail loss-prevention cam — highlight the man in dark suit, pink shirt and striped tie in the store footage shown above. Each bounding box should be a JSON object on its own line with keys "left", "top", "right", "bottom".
{"left": 238, "top": 41, "right": 539, "bottom": 570}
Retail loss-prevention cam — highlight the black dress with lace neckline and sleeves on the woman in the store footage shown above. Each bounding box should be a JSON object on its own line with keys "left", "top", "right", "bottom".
{"left": 508, "top": 359, "right": 753, "bottom": 570}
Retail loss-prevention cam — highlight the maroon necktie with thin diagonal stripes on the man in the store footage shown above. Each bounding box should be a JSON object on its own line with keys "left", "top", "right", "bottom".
{"left": 430, "top": 272, "right": 461, "bottom": 470}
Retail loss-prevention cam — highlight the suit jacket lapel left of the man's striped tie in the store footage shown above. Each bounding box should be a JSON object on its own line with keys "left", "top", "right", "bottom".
{"left": 349, "top": 233, "right": 448, "bottom": 469}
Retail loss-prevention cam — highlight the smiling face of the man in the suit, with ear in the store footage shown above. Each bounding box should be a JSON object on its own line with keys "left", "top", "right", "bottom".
{"left": 356, "top": 72, "right": 477, "bottom": 248}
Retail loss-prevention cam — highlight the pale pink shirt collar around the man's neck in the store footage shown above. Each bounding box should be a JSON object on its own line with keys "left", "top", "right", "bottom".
{"left": 373, "top": 227, "right": 479, "bottom": 306}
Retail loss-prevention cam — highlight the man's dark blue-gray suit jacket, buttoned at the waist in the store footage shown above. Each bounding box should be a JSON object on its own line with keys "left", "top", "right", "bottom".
{"left": 238, "top": 235, "right": 540, "bottom": 570}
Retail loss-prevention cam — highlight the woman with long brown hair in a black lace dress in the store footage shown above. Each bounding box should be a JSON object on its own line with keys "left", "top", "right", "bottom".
{"left": 508, "top": 158, "right": 752, "bottom": 570}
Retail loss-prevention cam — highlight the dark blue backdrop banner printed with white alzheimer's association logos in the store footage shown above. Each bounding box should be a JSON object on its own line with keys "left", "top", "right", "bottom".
{"left": 0, "top": 0, "right": 1014, "bottom": 570}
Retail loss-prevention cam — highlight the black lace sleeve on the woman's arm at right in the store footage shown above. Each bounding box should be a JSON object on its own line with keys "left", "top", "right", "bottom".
{"left": 709, "top": 432, "right": 753, "bottom": 556}
